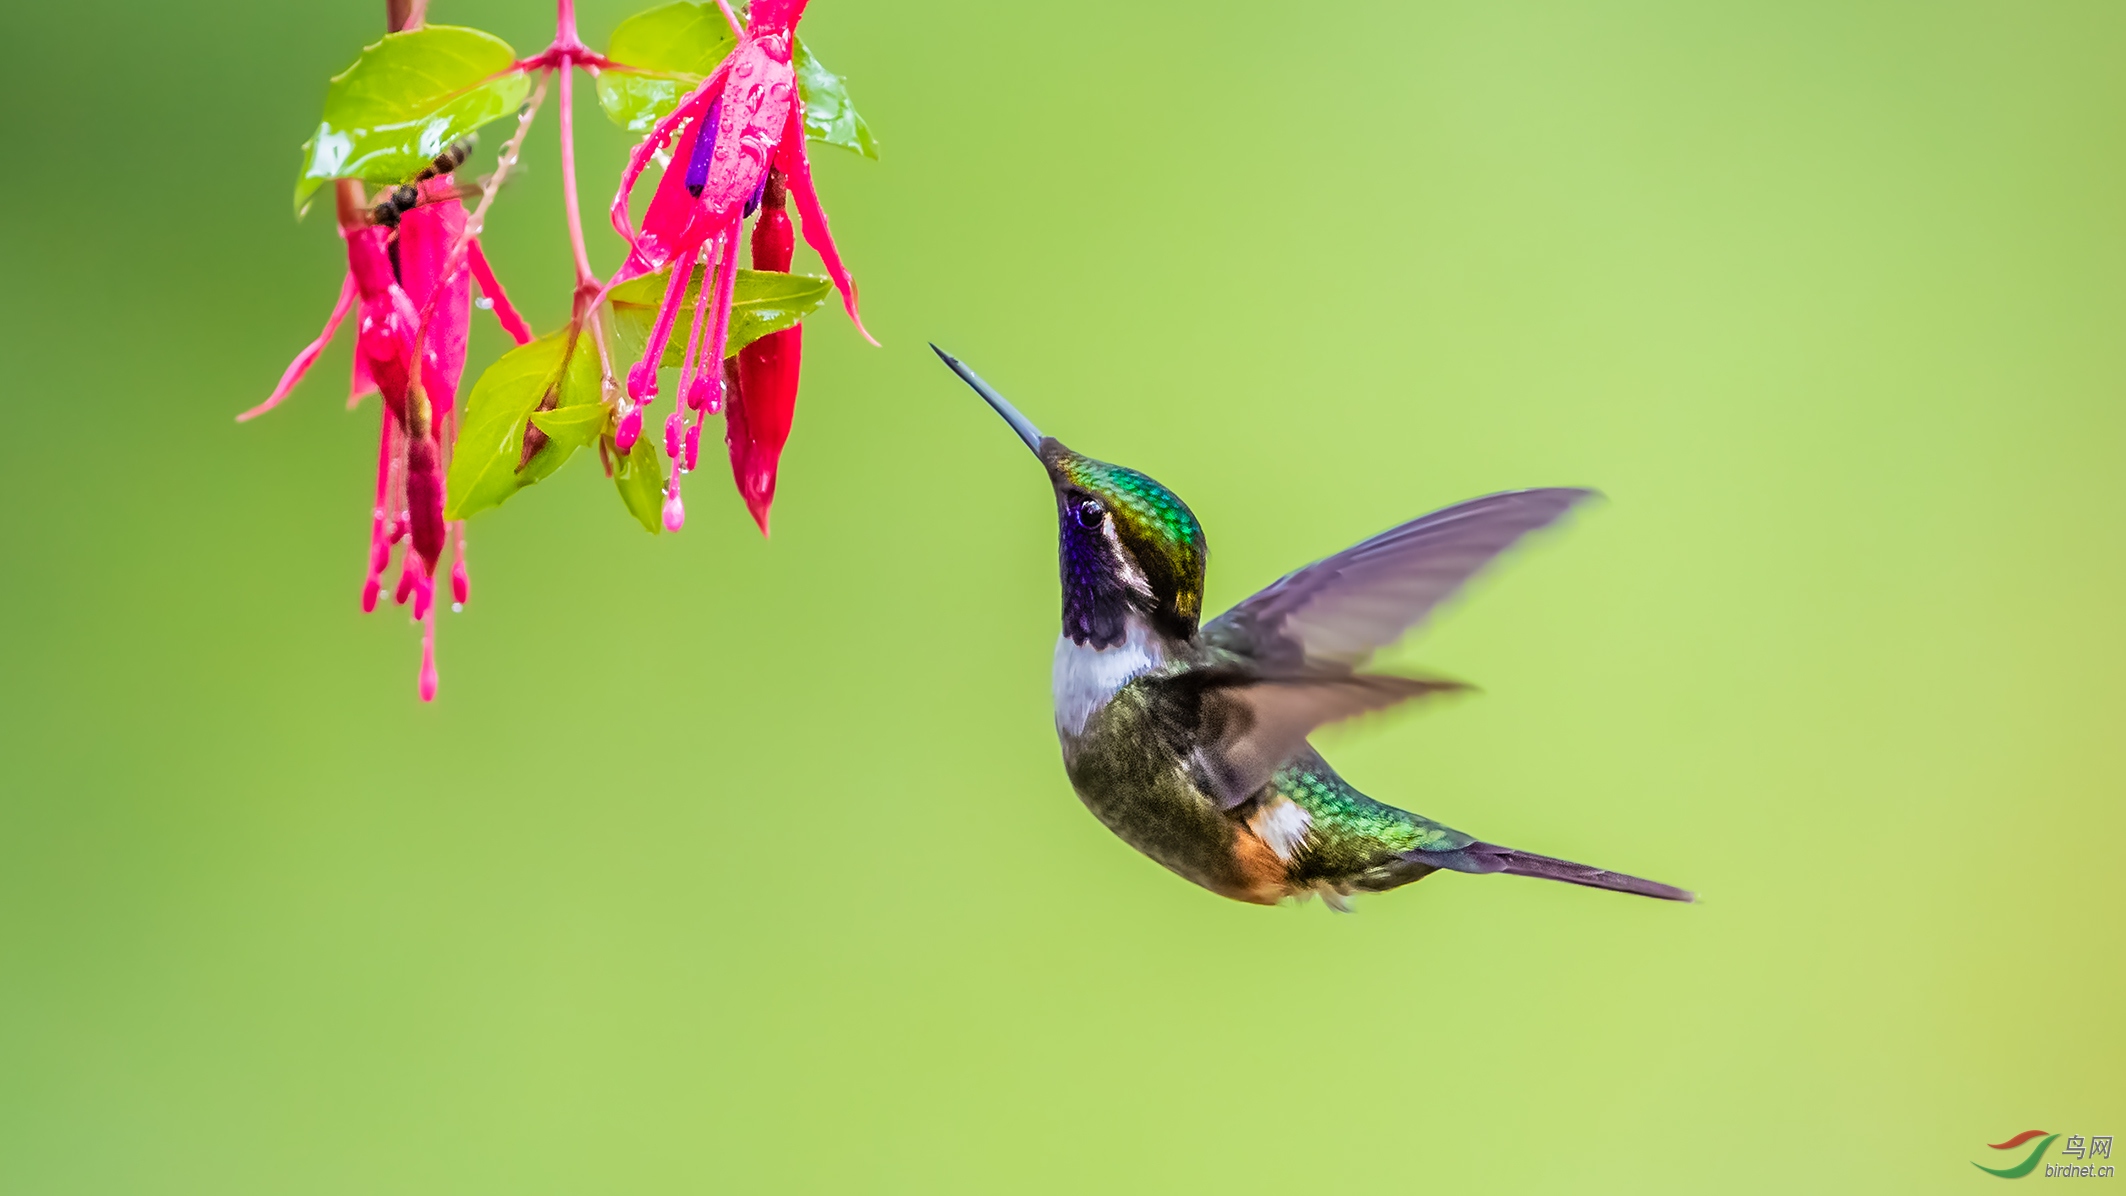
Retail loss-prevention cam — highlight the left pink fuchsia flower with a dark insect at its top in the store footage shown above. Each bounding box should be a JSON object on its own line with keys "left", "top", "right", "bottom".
{"left": 236, "top": 163, "right": 532, "bottom": 701}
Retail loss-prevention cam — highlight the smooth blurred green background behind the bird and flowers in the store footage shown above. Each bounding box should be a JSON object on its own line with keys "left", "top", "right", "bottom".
{"left": 0, "top": 0, "right": 2126, "bottom": 1194}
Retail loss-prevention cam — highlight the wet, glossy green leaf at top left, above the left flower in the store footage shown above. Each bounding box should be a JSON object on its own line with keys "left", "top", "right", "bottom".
{"left": 296, "top": 25, "right": 532, "bottom": 215}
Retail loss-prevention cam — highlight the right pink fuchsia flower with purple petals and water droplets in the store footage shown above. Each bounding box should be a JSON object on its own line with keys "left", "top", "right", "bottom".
{"left": 606, "top": 0, "right": 876, "bottom": 531}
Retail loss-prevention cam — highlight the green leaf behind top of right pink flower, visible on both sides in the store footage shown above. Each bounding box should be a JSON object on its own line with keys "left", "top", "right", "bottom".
{"left": 597, "top": 0, "right": 878, "bottom": 159}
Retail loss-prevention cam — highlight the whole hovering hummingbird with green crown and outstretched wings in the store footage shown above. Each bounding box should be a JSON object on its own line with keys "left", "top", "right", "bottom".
{"left": 931, "top": 344, "right": 1694, "bottom": 911}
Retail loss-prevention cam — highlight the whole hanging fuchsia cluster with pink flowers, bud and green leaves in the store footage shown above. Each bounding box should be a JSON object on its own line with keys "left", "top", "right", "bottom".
{"left": 250, "top": 0, "right": 876, "bottom": 701}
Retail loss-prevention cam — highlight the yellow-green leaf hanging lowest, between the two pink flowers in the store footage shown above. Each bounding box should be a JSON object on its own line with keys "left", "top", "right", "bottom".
{"left": 442, "top": 329, "right": 606, "bottom": 518}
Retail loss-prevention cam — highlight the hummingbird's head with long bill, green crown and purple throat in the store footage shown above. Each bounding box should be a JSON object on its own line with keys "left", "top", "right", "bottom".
{"left": 931, "top": 344, "right": 1210, "bottom": 648}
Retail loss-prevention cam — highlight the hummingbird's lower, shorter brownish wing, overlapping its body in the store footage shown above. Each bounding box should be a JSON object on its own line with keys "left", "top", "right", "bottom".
{"left": 1140, "top": 669, "right": 1469, "bottom": 809}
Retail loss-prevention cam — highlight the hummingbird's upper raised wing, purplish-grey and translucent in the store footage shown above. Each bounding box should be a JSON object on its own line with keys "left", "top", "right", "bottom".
{"left": 1201, "top": 489, "right": 1595, "bottom": 671}
